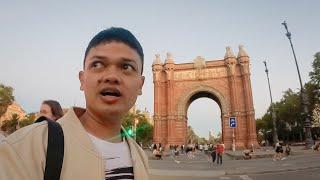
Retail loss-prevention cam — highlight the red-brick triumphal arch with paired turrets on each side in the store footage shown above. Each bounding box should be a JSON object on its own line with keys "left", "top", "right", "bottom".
{"left": 152, "top": 45, "right": 257, "bottom": 149}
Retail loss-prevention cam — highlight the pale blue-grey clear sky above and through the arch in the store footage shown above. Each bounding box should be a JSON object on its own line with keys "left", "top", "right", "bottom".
{"left": 0, "top": 0, "right": 320, "bottom": 137}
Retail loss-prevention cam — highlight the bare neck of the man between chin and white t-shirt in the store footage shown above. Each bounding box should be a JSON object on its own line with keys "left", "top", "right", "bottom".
{"left": 79, "top": 110, "right": 122, "bottom": 143}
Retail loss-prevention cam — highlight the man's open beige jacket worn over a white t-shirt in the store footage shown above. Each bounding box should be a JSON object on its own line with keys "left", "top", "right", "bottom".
{"left": 0, "top": 108, "right": 149, "bottom": 180}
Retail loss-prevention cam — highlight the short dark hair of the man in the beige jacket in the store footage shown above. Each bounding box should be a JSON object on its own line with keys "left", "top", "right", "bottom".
{"left": 83, "top": 27, "right": 144, "bottom": 74}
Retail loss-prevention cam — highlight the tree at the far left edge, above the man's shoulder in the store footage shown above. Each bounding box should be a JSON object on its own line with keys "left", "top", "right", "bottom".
{"left": 0, "top": 84, "right": 14, "bottom": 117}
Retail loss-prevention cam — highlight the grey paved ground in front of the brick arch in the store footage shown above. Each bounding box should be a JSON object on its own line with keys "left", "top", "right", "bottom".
{"left": 150, "top": 147, "right": 320, "bottom": 179}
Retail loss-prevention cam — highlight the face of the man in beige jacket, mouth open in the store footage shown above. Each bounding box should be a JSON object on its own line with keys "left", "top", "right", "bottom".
{"left": 79, "top": 41, "right": 144, "bottom": 119}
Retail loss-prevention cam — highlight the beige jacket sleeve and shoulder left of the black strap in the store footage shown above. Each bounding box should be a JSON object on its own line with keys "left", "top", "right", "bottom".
{"left": 0, "top": 123, "right": 48, "bottom": 180}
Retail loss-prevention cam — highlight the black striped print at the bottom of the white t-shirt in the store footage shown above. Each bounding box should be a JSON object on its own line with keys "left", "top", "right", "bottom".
{"left": 105, "top": 167, "right": 134, "bottom": 180}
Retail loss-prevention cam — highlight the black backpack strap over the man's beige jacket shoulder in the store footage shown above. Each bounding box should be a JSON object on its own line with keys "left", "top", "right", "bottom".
{"left": 35, "top": 116, "right": 64, "bottom": 180}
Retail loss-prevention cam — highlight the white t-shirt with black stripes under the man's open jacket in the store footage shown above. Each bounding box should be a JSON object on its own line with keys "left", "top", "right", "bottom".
{"left": 88, "top": 133, "right": 134, "bottom": 180}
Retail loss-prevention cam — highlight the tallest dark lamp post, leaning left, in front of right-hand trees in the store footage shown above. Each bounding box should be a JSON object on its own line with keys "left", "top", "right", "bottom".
{"left": 281, "top": 21, "right": 312, "bottom": 148}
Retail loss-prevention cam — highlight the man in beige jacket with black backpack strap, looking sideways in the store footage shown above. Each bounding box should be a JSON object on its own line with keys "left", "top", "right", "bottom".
{"left": 0, "top": 28, "right": 149, "bottom": 180}
